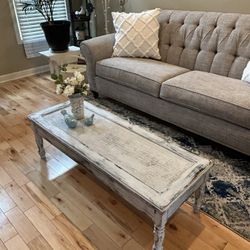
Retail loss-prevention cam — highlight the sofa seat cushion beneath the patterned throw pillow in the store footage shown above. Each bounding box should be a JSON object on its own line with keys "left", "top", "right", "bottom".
{"left": 96, "top": 57, "right": 189, "bottom": 97}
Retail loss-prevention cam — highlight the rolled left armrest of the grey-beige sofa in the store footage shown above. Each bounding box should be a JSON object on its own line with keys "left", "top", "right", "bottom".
{"left": 81, "top": 34, "right": 115, "bottom": 91}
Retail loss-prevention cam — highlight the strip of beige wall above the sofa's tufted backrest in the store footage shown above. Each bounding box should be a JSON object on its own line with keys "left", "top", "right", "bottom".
{"left": 127, "top": 0, "right": 250, "bottom": 13}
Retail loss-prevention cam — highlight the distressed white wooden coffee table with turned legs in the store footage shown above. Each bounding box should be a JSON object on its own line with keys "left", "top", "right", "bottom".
{"left": 29, "top": 102, "right": 211, "bottom": 250}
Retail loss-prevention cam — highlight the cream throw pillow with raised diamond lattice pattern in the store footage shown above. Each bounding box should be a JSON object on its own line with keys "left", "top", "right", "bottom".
{"left": 112, "top": 9, "right": 161, "bottom": 59}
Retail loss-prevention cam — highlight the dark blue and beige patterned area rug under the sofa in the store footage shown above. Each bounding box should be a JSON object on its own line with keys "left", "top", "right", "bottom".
{"left": 88, "top": 97, "right": 250, "bottom": 240}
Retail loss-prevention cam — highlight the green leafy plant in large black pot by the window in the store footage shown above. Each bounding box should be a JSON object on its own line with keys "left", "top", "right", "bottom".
{"left": 21, "top": 0, "right": 70, "bottom": 52}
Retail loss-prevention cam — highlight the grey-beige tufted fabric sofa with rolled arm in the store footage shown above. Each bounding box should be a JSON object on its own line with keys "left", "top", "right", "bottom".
{"left": 81, "top": 10, "right": 250, "bottom": 155}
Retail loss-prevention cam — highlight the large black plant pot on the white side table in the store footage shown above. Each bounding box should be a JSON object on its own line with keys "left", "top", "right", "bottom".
{"left": 41, "top": 20, "right": 70, "bottom": 52}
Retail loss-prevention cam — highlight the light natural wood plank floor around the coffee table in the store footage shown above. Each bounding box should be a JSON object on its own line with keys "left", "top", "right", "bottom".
{"left": 0, "top": 75, "right": 250, "bottom": 250}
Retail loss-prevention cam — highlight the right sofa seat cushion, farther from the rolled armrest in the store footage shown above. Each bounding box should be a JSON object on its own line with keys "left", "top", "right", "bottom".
{"left": 160, "top": 71, "right": 250, "bottom": 129}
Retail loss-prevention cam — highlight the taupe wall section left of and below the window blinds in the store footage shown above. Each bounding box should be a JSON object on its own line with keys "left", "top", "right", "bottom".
{"left": 0, "top": 0, "right": 47, "bottom": 75}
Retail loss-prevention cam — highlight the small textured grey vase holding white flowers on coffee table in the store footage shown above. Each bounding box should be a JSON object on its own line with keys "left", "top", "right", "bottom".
{"left": 69, "top": 94, "right": 84, "bottom": 120}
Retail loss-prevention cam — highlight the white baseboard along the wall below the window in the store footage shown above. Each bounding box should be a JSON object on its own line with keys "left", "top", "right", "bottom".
{"left": 0, "top": 65, "right": 49, "bottom": 83}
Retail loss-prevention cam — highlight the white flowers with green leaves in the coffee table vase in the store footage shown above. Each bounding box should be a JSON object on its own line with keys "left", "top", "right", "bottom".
{"left": 51, "top": 71, "right": 89, "bottom": 97}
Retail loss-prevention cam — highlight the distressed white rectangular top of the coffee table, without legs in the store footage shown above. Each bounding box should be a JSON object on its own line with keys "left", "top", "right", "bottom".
{"left": 29, "top": 102, "right": 210, "bottom": 210}
